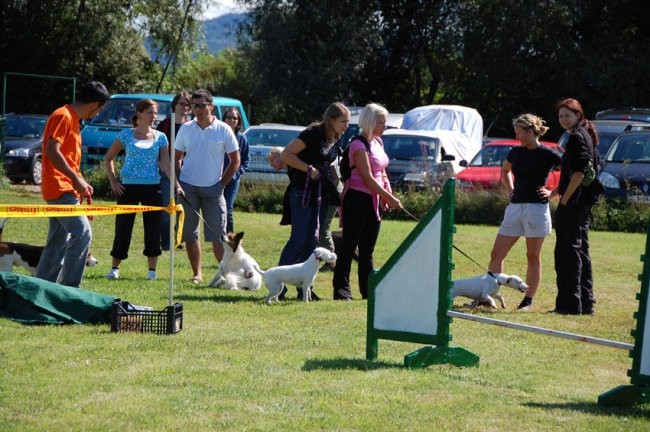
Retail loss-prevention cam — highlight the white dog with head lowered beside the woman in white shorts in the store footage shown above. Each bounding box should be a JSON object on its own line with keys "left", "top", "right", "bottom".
{"left": 450, "top": 272, "right": 528, "bottom": 309}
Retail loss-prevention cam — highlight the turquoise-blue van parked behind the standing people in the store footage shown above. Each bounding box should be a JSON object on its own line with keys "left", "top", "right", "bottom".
{"left": 81, "top": 93, "right": 248, "bottom": 171}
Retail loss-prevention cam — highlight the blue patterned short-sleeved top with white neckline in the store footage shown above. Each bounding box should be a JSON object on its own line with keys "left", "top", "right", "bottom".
{"left": 117, "top": 128, "right": 169, "bottom": 185}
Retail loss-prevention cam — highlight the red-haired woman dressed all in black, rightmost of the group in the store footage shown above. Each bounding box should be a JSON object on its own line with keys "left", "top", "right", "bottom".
{"left": 551, "top": 99, "right": 599, "bottom": 315}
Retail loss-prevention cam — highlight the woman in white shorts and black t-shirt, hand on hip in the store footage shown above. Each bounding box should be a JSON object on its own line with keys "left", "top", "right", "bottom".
{"left": 488, "top": 114, "right": 562, "bottom": 311}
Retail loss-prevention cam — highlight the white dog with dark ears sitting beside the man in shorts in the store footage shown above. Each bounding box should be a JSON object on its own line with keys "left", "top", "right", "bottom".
{"left": 208, "top": 232, "right": 262, "bottom": 290}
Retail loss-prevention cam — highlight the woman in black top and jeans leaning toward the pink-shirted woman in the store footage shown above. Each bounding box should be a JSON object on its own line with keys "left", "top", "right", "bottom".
{"left": 278, "top": 102, "right": 350, "bottom": 299}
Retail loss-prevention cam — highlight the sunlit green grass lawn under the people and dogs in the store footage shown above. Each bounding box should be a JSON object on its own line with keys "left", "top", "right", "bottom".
{"left": 0, "top": 186, "right": 650, "bottom": 432}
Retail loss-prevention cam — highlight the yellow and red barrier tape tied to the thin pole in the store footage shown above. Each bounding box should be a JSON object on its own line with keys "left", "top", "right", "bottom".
{"left": 0, "top": 199, "right": 185, "bottom": 246}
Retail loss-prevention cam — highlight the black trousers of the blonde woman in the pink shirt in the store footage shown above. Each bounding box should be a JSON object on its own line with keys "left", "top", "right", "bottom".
{"left": 333, "top": 189, "right": 381, "bottom": 299}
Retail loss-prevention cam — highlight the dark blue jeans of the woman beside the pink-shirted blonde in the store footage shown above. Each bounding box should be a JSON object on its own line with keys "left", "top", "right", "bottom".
{"left": 278, "top": 187, "right": 329, "bottom": 265}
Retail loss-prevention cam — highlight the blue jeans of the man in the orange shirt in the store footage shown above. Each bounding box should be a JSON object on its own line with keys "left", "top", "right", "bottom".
{"left": 36, "top": 193, "right": 93, "bottom": 287}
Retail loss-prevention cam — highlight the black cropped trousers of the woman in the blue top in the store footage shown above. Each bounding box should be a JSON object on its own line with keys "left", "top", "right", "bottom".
{"left": 111, "top": 184, "right": 162, "bottom": 260}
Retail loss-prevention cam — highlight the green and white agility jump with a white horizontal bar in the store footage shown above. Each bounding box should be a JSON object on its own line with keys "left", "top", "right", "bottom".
{"left": 366, "top": 178, "right": 650, "bottom": 406}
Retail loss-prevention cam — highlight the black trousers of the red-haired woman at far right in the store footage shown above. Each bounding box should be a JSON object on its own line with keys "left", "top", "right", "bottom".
{"left": 555, "top": 202, "right": 595, "bottom": 315}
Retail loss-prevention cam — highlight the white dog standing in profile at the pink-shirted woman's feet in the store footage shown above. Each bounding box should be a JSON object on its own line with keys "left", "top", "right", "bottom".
{"left": 256, "top": 247, "right": 336, "bottom": 304}
